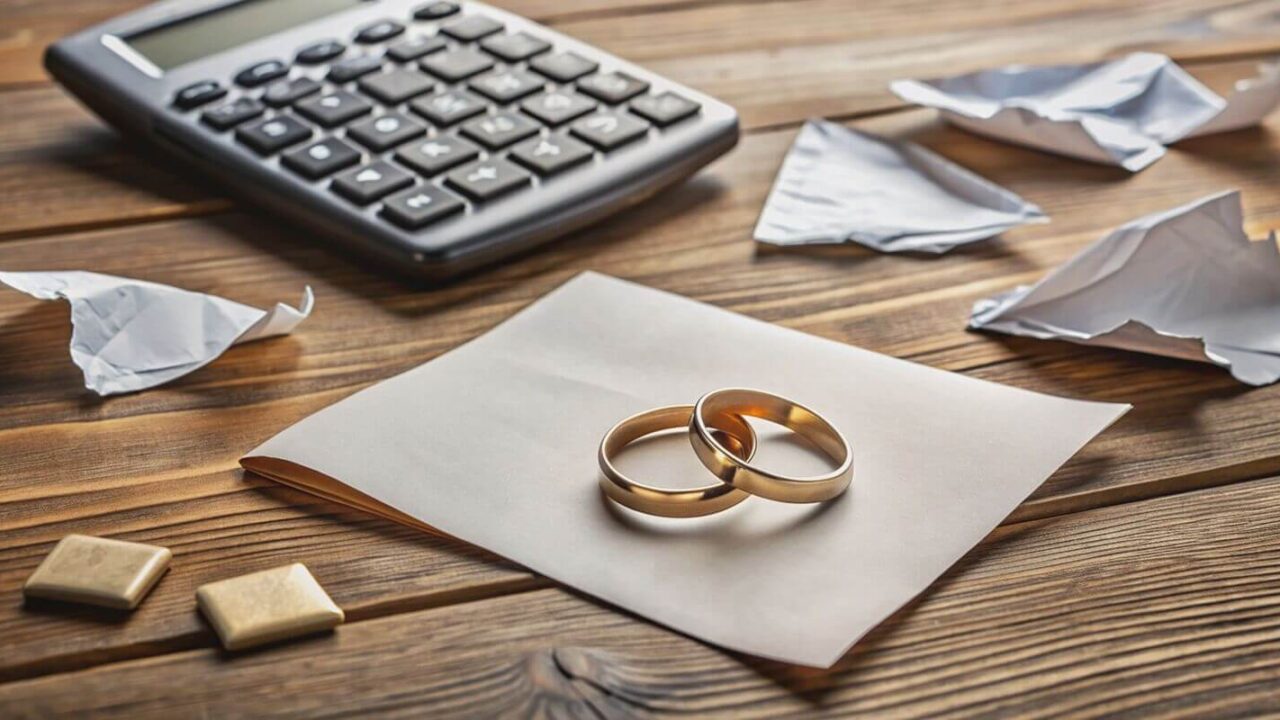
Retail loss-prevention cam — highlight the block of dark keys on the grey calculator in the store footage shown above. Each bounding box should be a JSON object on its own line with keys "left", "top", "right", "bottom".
{"left": 167, "top": 1, "right": 700, "bottom": 238}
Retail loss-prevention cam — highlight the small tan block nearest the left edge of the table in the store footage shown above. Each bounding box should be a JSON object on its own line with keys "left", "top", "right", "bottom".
{"left": 22, "top": 536, "right": 173, "bottom": 610}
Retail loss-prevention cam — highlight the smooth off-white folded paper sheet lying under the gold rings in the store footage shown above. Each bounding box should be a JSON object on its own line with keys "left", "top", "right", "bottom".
{"left": 242, "top": 274, "right": 1128, "bottom": 666}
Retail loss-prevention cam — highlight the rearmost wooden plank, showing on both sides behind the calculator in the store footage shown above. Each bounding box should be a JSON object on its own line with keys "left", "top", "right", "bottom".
{"left": 0, "top": 0, "right": 1280, "bottom": 91}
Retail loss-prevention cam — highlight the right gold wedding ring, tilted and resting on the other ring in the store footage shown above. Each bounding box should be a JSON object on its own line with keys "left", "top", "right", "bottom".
{"left": 689, "top": 388, "right": 854, "bottom": 502}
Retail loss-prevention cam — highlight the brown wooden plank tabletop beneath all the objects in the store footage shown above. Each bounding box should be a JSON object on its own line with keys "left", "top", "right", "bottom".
{"left": 0, "top": 0, "right": 1280, "bottom": 717}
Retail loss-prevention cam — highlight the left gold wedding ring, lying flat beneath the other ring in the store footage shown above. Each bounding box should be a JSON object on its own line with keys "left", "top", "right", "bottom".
{"left": 599, "top": 405, "right": 755, "bottom": 518}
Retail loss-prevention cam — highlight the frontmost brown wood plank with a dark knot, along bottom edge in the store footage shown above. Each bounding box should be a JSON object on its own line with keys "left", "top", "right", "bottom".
{"left": 0, "top": 478, "right": 1280, "bottom": 719}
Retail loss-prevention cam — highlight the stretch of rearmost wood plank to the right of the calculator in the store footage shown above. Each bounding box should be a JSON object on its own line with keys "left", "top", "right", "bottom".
{"left": 557, "top": 0, "right": 1280, "bottom": 127}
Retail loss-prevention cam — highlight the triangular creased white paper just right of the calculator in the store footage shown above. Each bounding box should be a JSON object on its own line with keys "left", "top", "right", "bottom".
{"left": 755, "top": 120, "right": 1047, "bottom": 254}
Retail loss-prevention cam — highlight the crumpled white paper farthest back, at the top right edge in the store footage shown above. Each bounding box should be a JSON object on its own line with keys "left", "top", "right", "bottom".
{"left": 890, "top": 53, "right": 1280, "bottom": 172}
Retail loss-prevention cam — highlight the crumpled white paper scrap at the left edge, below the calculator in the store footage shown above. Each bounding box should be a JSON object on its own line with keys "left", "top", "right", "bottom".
{"left": 0, "top": 270, "right": 315, "bottom": 396}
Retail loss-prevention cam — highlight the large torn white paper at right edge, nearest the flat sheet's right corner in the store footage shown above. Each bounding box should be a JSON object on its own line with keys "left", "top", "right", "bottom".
{"left": 969, "top": 191, "right": 1280, "bottom": 386}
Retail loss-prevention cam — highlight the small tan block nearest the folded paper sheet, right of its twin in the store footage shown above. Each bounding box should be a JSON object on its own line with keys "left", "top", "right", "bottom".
{"left": 196, "top": 562, "right": 344, "bottom": 650}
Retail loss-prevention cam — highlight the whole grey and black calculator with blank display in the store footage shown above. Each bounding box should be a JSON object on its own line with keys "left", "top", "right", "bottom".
{"left": 45, "top": 0, "right": 739, "bottom": 278}
